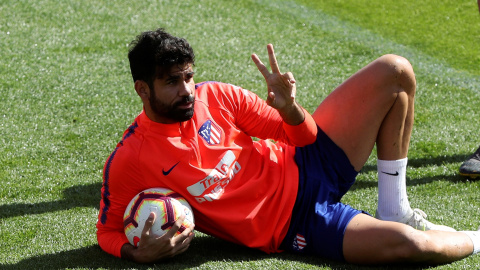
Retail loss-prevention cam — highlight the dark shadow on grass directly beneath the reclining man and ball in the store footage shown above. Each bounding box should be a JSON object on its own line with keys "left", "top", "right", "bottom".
{"left": 1, "top": 235, "right": 423, "bottom": 270}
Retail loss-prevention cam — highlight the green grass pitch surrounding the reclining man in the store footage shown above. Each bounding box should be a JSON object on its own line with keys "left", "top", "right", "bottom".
{"left": 0, "top": 0, "right": 480, "bottom": 269}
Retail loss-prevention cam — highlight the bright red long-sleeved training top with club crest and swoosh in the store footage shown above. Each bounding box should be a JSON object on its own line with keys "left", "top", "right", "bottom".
{"left": 97, "top": 82, "right": 317, "bottom": 257}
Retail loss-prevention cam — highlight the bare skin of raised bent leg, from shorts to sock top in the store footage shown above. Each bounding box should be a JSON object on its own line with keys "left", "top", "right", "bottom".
{"left": 313, "top": 55, "right": 416, "bottom": 171}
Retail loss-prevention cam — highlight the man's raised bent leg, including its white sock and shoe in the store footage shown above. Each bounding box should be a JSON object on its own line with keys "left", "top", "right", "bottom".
{"left": 313, "top": 54, "right": 454, "bottom": 231}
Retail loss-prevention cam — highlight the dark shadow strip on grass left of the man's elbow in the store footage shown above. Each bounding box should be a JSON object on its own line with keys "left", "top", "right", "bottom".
{"left": 0, "top": 183, "right": 102, "bottom": 218}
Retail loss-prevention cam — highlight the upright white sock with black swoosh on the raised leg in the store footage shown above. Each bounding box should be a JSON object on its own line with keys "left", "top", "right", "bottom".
{"left": 377, "top": 158, "right": 412, "bottom": 221}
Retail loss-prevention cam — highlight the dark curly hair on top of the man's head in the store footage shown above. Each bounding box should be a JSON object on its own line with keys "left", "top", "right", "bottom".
{"left": 128, "top": 28, "right": 195, "bottom": 87}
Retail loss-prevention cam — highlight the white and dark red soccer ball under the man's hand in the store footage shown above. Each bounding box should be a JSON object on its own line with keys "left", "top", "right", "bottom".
{"left": 123, "top": 188, "right": 194, "bottom": 247}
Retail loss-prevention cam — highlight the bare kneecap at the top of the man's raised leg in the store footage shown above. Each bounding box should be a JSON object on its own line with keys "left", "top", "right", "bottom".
{"left": 377, "top": 54, "right": 416, "bottom": 96}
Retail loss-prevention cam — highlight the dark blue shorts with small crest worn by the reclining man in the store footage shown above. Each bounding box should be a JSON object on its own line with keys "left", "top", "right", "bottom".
{"left": 280, "top": 128, "right": 362, "bottom": 261}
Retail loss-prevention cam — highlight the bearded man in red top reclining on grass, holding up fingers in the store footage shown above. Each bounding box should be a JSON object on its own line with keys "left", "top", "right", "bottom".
{"left": 97, "top": 29, "right": 480, "bottom": 264}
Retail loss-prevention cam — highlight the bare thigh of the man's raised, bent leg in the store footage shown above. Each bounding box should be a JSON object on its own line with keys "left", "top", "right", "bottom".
{"left": 313, "top": 55, "right": 413, "bottom": 170}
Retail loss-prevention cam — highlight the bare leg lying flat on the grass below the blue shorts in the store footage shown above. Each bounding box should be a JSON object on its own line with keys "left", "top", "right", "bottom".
{"left": 343, "top": 214, "right": 473, "bottom": 264}
